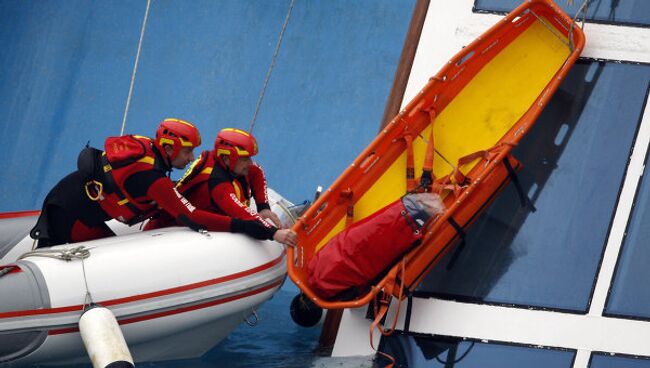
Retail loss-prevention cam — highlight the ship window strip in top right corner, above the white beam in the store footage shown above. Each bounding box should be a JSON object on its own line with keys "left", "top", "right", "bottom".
{"left": 474, "top": 0, "right": 650, "bottom": 26}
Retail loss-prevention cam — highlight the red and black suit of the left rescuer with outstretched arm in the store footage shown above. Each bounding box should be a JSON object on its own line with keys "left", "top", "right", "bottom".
{"left": 32, "top": 137, "right": 274, "bottom": 247}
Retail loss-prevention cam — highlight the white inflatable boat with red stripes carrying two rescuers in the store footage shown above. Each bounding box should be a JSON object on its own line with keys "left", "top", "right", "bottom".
{"left": 0, "top": 190, "right": 289, "bottom": 366}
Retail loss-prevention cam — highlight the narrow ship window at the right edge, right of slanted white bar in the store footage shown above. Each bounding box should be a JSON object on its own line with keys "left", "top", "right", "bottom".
{"left": 605, "top": 81, "right": 650, "bottom": 318}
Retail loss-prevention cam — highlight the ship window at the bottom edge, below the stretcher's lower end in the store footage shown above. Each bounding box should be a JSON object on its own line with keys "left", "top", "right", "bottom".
{"left": 379, "top": 333, "right": 575, "bottom": 368}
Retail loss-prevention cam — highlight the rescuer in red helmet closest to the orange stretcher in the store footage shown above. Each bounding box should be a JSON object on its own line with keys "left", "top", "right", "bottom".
{"left": 148, "top": 128, "right": 295, "bottom": 240}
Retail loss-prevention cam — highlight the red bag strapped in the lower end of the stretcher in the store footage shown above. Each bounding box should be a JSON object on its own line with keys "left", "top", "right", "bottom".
{"left": 308, "top": 200, "right": 422, "bottom": 298}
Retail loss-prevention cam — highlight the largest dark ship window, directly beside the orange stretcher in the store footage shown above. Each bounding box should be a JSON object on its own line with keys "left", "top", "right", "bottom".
{"left": 416, "top": 61, "right": 650, "bottom": 312}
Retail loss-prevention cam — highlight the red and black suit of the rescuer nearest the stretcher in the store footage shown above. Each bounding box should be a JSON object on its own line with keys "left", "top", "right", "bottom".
{"left": 148, "top": 151, "right": 277, "bottom": 232}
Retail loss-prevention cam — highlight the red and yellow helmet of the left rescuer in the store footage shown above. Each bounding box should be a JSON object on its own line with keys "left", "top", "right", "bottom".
{"left": 154, "top": 118, "right": 201, "bottom": 161}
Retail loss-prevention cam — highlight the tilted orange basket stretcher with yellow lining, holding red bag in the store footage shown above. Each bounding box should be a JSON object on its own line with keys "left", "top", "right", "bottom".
{"left": 288, "top": 0, "right": 585, "bottom": 309}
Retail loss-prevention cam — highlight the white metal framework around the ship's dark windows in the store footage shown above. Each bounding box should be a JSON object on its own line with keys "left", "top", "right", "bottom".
{"left": 332, "top": 0, "right": 650, "bottom": 368}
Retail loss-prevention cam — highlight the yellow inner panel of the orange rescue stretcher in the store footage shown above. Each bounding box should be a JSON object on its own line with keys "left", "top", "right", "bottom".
{"left": 316, "top": 19, "right": 570, "bottom": 251}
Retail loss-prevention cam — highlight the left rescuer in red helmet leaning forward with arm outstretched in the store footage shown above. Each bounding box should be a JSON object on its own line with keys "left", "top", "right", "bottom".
{"left": 30, "top": 119, "right": 294, "bottom": 247}
